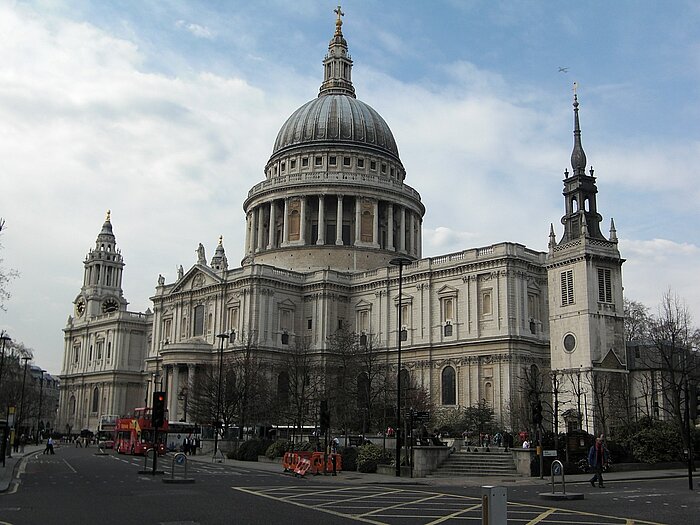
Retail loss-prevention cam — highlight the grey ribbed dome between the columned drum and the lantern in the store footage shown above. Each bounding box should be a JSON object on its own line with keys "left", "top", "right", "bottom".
{"left": 272, "top": 93, "right": 399, "bottom": 160}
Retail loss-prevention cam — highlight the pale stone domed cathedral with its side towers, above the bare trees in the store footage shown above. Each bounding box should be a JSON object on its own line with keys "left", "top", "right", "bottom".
{"left": 60, "top": 14, "right": 622, "bottom": 436}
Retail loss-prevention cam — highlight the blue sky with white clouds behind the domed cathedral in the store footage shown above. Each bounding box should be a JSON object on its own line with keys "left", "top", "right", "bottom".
{"left": 0, "top": 0, "right": 700, "bottom": 374}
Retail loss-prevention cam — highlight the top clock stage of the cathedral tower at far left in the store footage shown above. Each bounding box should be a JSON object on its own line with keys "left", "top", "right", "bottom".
{"left": 74, "top": 211, "right": 128, "bottom": 320}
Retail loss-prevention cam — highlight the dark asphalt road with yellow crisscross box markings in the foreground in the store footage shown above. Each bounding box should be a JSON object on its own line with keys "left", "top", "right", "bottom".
{"left": 0, "top": 447, "right": 700, "bottom": 525}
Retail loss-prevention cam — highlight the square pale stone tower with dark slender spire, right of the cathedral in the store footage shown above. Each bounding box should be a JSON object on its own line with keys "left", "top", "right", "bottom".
{"left": 546, "top": 94, "right": 625, "bottom": 432}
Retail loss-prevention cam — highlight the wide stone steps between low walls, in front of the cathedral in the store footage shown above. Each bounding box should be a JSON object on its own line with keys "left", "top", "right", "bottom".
{"left": 430, "top": 447, "right": 518, "bottom": 478}
